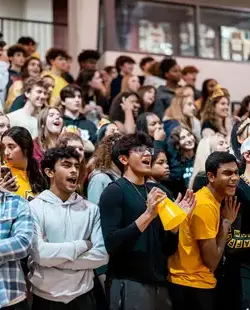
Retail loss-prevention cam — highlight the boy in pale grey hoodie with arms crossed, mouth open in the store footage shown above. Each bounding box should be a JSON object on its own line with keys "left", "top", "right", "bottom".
{"left": 29, "top": 147, "right": 108, "bottom": 310}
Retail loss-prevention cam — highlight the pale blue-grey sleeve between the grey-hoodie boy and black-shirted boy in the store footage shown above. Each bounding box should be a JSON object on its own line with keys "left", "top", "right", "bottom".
{"left": 88, "top": 173, "right": 112, "bottom": 205}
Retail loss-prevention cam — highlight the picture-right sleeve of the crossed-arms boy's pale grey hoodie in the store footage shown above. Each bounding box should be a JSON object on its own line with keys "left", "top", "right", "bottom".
{"left": 58, "top": 206, "right": 108, "bottom": 270}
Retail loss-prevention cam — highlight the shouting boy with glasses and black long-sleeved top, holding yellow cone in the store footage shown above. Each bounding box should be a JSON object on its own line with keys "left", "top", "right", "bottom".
{"left": 99, "top": 132, "right": 195, "bottom": 310}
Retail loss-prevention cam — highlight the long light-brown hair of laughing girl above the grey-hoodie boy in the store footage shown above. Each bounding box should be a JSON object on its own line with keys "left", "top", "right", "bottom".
{"left": 37, "top": 107, "right": 61, "bottom": 151}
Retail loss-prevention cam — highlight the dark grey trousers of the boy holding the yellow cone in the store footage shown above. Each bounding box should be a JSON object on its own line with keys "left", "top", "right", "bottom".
{"left": 106, "top": 279, "right": 172, "bottom": 310}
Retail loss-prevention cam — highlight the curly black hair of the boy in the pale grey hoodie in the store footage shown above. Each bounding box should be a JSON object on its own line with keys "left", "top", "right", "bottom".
{"left": 41, "top": 146, "right": 80, "bottom": 183}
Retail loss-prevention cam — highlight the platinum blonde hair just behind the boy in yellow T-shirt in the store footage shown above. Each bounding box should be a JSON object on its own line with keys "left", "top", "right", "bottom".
{"left": 189, "top": 133, "right": 225, "bottom": 188}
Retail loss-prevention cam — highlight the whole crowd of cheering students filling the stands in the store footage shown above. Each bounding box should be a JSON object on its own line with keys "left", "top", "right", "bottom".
{"left": 0, "top": 37, "right": 250, "bottom": 310}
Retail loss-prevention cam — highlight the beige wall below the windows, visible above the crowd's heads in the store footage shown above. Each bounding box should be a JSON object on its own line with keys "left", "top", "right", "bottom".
{"left": 101, "top": 51, "right": 250, "bottom": 101}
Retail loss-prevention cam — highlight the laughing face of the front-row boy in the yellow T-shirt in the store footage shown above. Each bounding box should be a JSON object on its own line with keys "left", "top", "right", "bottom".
{"left": 207, "top": 162, "right": 239, "bottom": 197}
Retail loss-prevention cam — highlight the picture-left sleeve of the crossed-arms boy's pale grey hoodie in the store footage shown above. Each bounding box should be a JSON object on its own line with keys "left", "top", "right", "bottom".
{"left": 30, "top": 204, "right": 88, "bottom": 267}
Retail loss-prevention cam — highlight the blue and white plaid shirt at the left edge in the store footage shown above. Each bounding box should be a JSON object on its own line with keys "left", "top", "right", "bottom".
{"left": 0, "top": 189, "right": 33, "bottom": 308}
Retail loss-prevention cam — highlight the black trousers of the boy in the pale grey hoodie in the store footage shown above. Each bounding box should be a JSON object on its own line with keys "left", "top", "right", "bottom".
{"left": 32, "top": 291, "right": 96, "bottom": 310}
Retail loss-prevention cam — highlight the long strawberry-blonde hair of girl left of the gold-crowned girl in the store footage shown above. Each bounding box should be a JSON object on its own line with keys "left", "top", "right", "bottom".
{"left": 164, "top": 87, "right": 193, "bottom": 132}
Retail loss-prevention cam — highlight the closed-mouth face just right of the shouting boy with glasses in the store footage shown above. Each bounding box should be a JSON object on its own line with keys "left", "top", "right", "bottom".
{"left": 150, "top": 152, "right": 170, "bottom": 182}
